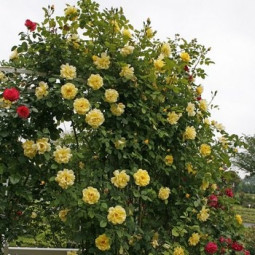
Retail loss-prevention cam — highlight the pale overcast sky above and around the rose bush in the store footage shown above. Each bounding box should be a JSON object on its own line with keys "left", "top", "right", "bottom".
{"left": 0, "top": 0, "right": 255, "bottom": 135}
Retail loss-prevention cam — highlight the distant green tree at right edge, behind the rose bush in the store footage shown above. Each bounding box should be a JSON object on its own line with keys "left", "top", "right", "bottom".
{"left": 234, "top": 135, "right": 255, "bottom": 175}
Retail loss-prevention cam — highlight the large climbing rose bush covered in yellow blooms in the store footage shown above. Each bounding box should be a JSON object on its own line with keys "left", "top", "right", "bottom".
{"left": 0, "top": 0, "right": 250, "bottom": 255}
